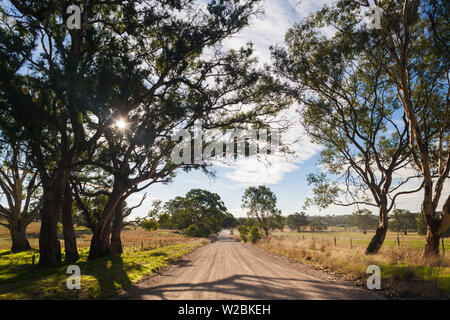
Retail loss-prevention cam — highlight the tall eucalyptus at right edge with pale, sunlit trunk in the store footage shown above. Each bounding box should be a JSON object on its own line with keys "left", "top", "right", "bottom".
{"left": 286, "top": 0, "right": 450, "bottom": 256}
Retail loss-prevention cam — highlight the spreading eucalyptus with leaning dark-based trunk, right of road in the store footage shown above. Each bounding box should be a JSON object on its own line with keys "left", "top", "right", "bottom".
{"left": 273, "top": 33, "right": 421, "bottom": 254}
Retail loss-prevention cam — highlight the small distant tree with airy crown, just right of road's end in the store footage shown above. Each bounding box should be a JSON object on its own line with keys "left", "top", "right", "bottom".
{"left": 242, "top": 186, "right": 284, "bottom": 237}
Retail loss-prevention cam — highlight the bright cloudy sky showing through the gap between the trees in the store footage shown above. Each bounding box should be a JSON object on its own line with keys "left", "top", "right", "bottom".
{"left": 128, "top": 0, "right": 450, "bottom": 217}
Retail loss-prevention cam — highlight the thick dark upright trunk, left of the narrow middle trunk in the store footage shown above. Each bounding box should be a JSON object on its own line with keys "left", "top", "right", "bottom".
{"left": 39, "top": 188, "right": 63, "bottom": 267}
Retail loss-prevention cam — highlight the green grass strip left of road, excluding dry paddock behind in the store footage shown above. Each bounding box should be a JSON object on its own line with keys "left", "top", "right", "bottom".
{"left": 0, "top": 240, "right": 202, "bottom": 299}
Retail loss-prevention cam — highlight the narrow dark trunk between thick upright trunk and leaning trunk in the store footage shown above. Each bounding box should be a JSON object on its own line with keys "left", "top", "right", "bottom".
{"left": 62, "top": 183, "right": 80, "bottom": 262}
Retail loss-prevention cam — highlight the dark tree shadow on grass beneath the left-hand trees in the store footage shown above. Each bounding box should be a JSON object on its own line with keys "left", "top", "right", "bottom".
{"left": 0, "top": 251, "right": 132, "bottom": 299}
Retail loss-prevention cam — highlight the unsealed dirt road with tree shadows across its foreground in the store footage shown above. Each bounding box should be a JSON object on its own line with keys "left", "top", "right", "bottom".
{"left": 122, "top": 231, "right": 382, "bottom": 300}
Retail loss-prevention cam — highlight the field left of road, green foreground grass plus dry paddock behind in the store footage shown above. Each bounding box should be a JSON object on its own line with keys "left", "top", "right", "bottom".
{"left": 0, "top": 223, "right": 209, "bottom": 299}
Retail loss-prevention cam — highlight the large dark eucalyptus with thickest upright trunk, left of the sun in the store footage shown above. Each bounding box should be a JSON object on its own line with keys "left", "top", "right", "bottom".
{"left": 0, "top": 1, "right": 153, "bottom": 266}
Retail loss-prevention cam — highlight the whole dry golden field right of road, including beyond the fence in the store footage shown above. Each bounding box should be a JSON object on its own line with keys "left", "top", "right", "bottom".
{"left": 257, "top": 231, "right": 450, "bottom": 299}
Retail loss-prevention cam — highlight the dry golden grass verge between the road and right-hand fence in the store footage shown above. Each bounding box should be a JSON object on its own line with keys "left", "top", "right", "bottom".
{"left": 258, "top": 236, "right": 450, "bottom": 299}
